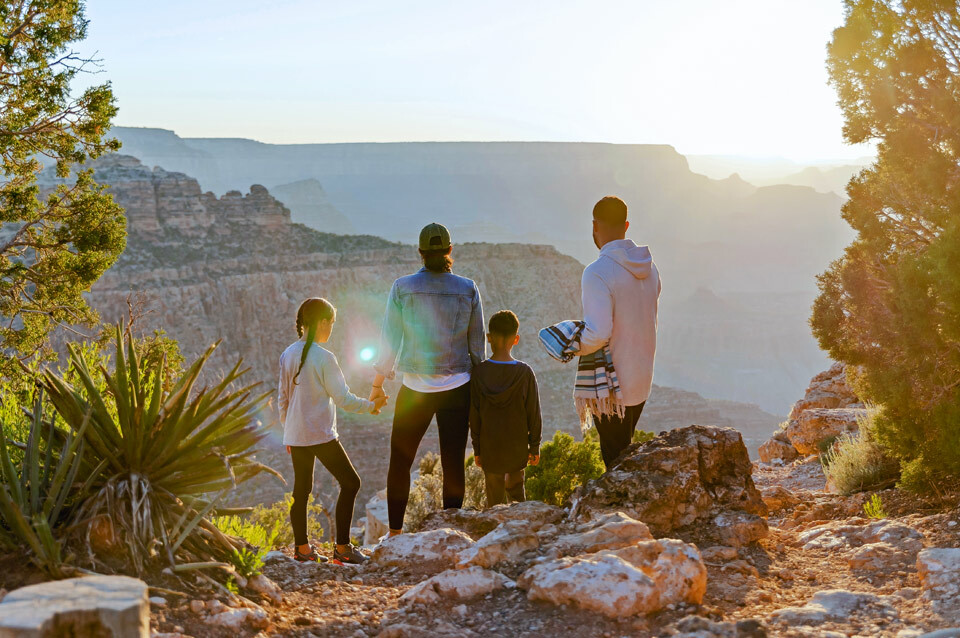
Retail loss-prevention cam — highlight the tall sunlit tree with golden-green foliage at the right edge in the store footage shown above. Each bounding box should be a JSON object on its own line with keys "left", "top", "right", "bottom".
{"left": 811, "top": 0, "right": 960, "bottom": 486}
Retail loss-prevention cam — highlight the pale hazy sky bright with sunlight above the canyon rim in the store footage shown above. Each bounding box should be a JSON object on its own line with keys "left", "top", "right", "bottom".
{"left": 80, "top": 0, "right": 869, "bottom": 161}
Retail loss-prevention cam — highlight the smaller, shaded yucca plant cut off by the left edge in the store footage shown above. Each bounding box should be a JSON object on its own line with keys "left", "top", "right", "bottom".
{"left": 0, "top": 393, "right": 94, "bottom": 578}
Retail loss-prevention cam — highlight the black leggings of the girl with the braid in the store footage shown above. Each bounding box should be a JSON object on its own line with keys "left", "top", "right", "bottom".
{"left": 290, "top": 440, "right": 360, "bottom": 545}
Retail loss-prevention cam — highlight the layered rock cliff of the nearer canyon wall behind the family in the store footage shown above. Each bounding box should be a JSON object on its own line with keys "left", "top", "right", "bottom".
{"left": 63, "top": 155, "right": 778, "bottom": 447}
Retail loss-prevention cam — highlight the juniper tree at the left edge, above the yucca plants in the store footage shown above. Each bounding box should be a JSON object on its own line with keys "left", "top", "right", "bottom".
{"left": 0, "top": 0, "right": 126, "bottom": 373}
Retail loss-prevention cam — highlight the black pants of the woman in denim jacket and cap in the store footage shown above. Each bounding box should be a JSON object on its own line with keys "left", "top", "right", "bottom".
{"left": 387, "top": 383, "right": 470, "bottom": 529}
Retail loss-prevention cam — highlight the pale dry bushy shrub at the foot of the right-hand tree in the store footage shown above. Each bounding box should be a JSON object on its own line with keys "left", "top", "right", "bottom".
{"left": 820, "top": 407, "right": 898, "bottom": 494}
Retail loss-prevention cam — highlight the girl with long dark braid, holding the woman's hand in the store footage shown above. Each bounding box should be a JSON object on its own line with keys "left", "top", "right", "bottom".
{"left": 278, "top": 297, "right": 388, "bottom": 564}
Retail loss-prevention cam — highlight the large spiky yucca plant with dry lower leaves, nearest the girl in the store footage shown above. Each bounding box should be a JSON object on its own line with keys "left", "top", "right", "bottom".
{"left": 43, "top": 325, "right": 282, "bottom": 573}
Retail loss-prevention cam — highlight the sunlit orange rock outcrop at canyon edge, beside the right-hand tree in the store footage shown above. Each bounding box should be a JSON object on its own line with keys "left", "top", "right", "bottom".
{"left": 759, "top": 363, "right": 866, "bottom": 463}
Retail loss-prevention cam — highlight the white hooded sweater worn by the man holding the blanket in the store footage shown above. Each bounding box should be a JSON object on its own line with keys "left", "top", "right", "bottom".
{"left": 578, "top": 239, "right": 661, "bottom": 406}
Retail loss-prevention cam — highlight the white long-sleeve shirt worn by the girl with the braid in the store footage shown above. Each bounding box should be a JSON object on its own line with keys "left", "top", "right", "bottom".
{"left": 277, "top": 339, "right": 373, "bottom": 446}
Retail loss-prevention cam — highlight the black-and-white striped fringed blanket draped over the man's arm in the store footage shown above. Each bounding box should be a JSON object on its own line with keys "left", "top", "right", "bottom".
{"left": 540, "top": 321, "right": 625, "bottom": 432}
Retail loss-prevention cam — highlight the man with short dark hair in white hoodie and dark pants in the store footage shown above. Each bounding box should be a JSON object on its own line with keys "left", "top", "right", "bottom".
{"left": 578, "top": 197, "right": 661, "bottom": 469}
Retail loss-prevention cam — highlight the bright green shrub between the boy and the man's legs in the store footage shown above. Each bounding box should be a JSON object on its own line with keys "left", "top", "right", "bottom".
{"left": 525, "top": 430, "right": 604, "bottom": 506}
